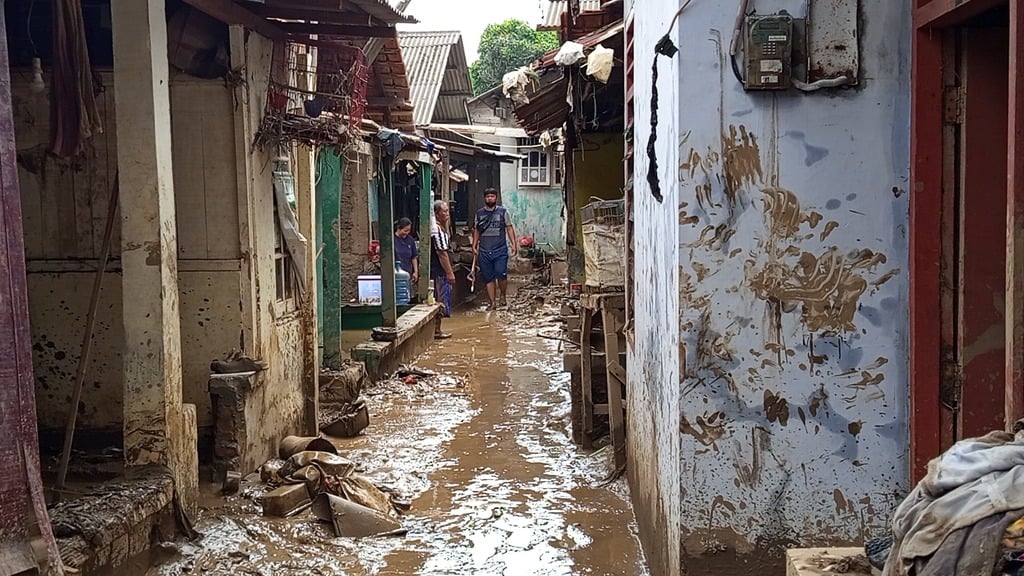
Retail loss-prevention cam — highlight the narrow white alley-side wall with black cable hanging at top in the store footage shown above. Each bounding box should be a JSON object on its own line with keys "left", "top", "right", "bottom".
{"left": 622, "top": 0, "right": 681, "bottom": 576}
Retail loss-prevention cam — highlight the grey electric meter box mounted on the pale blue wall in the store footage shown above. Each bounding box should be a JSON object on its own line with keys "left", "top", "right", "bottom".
{"left": 743, "top": 13, "right": 794, "bottom": 90}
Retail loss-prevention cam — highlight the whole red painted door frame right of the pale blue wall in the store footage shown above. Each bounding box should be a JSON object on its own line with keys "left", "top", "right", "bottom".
{"left": 910, "top": 0, "right": 1024, "bottom": 481}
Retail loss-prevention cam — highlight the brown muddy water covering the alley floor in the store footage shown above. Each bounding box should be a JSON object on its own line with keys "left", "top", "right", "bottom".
{"left": 150, "top": 297, "right": 646, "bottom": 576}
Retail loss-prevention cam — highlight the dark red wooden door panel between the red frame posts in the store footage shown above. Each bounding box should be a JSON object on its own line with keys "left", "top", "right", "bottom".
{"left": 957, "top": 28, "right": 1010, "bottom": 438}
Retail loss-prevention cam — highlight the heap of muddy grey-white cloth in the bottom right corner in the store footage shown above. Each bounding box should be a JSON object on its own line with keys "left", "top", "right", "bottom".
{"left": 883, "top": 431, "right": 1024, "bottom": 576}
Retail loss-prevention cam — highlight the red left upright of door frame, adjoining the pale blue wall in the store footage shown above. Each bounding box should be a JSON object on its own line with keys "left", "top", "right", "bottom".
{"left": 910, "top": 23, "right": 942, "bottom": 482}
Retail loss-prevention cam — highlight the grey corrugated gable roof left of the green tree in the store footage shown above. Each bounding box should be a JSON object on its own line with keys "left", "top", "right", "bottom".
{"left": 398, "top": 32, "right": 473, "bottom": 125}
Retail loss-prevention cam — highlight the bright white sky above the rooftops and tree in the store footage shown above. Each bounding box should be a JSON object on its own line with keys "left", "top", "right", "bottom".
{"left": 391, "top": 0, "right": 549, "bottom": 64}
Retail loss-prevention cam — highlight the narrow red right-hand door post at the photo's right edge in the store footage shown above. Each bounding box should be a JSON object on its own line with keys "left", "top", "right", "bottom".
{"left": 1004, "top": 1, "right": 1024, "bottom": 422}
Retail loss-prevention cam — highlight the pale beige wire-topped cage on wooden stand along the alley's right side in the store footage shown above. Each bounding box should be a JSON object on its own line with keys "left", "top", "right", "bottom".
{"left": 580, "top": 200, "right": 626, "bottom": 289}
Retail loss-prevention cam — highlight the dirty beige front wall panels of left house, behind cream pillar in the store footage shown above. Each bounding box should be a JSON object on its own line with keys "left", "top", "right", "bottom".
{"left": 13, "top": 74, "right": 247, "bottom": 431}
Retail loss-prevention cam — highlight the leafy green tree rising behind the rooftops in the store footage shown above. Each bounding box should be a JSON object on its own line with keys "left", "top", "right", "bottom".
{"left": 469, "top": 19, "right": 558, "bottom": 94}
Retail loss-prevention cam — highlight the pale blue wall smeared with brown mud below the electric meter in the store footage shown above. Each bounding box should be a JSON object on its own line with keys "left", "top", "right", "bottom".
{"left": 667, "top": 0, "right": 910, "bottom": 576}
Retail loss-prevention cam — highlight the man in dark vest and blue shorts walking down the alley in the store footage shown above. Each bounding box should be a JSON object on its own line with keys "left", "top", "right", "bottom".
{"left": 473, "top": 188, "right": 517, "bottom": 310}
